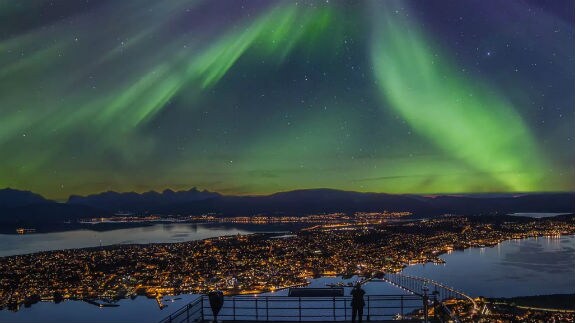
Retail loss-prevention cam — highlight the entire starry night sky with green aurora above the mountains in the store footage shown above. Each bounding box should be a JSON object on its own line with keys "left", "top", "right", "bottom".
{"left": 0, "top": 0, "right": 575, "bottom": 199}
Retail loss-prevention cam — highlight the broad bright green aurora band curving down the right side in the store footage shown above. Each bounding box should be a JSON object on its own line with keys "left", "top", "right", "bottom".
{"left": 371, "top": 1, "right": 548, "bottom": 191}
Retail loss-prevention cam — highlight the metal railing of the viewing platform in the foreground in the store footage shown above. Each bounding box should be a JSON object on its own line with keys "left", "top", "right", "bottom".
{"left": 160, "top": 295, "right": 423, "bottom": 323}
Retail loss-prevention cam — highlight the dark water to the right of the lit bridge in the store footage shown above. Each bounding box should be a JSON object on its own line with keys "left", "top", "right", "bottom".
{"left": 403, "top": 236, "right": 575, "bottom": 297}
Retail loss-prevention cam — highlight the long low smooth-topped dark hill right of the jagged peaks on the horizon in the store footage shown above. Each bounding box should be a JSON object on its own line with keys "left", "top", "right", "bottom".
{"left": 173, "top": 189, "right": 575, "bottom": 216}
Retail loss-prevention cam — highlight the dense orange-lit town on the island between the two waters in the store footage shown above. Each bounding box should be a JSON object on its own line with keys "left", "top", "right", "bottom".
{"left": 0, "top": 215, "right": 575, "bottom": 316}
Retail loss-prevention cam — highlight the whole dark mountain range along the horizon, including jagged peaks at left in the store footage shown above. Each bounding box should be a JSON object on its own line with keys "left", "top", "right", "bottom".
{"left": 0, "top": 188, "right": 575, "bottom": 223}
